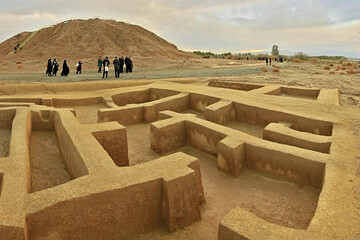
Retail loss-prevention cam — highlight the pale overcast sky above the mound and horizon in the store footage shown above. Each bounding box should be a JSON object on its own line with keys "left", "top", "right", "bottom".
{"left": 0, "top": 0, "right": 360, "bottom": 57}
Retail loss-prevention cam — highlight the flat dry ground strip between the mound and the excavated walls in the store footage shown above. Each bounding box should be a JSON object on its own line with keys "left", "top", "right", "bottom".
{"left": 0, "top": 58, "right": 360, "bottom": 106}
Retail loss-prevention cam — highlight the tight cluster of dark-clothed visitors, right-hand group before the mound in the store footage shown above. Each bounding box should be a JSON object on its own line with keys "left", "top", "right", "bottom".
{"left": 98, "top": 56, "right": 133, "bottom": 78}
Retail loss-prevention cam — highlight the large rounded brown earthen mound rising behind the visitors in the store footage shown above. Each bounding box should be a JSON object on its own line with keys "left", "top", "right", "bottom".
{"left": 0, "top": 19, "right": 194, "bottom": 69}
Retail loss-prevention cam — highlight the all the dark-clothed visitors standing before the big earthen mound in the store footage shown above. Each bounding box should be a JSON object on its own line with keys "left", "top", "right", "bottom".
{"left": 46, "top": 56, "right": 133, "bottom": 78}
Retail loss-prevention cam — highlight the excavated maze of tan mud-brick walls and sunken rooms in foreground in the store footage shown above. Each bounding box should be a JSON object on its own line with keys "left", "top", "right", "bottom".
{"left": 0, "top": 79, "right": 360, "bottom": 240}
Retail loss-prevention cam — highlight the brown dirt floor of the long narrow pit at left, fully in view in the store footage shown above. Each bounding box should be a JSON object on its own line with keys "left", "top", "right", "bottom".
{"left": 30, "top": 131, "right": 70, "bottom": 192}
